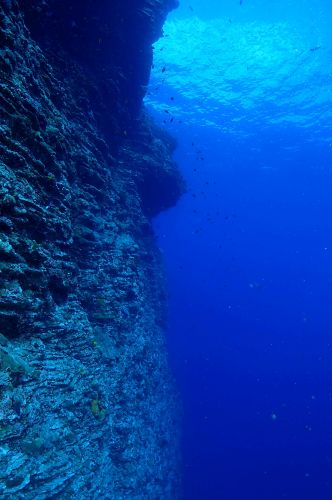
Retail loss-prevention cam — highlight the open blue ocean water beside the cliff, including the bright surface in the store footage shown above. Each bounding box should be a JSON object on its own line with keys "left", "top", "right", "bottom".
{"left": 146, "top": 0, "right": 332, "bottom": 500}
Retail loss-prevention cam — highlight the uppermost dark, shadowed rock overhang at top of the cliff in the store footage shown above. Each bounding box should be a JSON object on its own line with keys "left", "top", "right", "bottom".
{"left": 20, "top": 0, "right": 178, "bottom": 128}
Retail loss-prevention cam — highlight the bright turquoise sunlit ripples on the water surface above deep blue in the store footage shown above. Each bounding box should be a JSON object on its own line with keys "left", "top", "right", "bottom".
{"left": 147, "top": 18, "right": 332, "bottom": 141}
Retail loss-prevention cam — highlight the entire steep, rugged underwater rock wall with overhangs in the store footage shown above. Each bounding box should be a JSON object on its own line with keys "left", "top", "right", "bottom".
{"left": 0, "top": 0, "right": 183, "bottom": 500}
